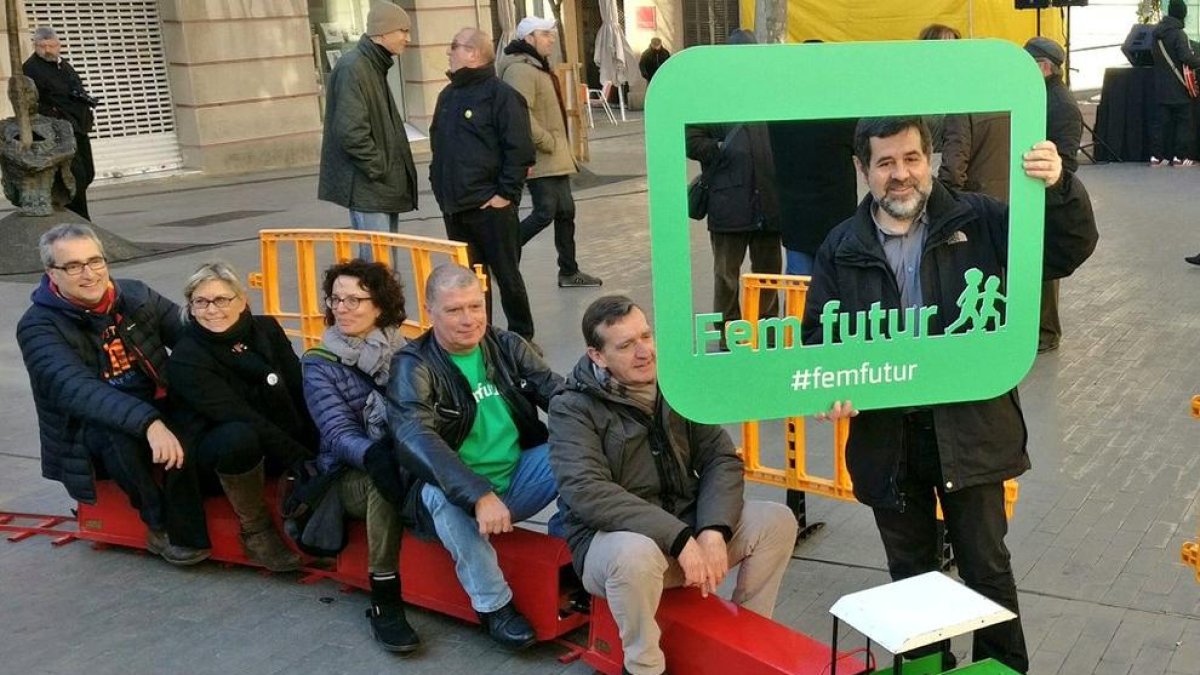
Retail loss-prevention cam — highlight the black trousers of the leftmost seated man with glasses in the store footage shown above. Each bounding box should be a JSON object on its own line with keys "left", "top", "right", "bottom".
{"left": 84, "top": 426, "right": 211, "bottom": 549}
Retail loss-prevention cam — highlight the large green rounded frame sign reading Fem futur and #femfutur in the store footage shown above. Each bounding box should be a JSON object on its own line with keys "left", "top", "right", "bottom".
{"left": 646, "top": 40, "right": 1045, "bottom": 424}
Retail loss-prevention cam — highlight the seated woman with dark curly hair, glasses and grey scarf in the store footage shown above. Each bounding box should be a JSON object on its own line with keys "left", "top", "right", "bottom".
{"left": 304, "top": 259, "right": 420, "bottom": 653}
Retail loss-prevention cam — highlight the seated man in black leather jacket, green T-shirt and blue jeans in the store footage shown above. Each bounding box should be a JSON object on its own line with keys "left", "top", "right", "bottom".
{"left": 388, "top": 263, "right": 563, "bottom": 649}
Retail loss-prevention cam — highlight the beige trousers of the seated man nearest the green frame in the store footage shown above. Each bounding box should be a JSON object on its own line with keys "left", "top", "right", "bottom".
{"left": 583, "top": 501, "right": 796, "bottom": 675}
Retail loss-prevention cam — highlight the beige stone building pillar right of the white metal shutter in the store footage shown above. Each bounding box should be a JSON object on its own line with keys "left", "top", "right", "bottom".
{"left": 160, "top": 0, "right": 322, "bottom": 173}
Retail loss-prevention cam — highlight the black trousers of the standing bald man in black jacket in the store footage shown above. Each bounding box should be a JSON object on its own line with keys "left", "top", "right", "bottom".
{"left": 444, "top": 204, "right": 533, "bottom": 340}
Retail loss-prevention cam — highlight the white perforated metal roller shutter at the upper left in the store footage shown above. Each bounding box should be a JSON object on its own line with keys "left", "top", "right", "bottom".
{"left": 25, "top": 0, "right": 184, "bottom": 179}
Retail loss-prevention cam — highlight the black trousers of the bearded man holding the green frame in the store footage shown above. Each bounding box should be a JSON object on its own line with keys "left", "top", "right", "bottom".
{"left": 875, "top": 412, "right": 1030, "bottom": 673}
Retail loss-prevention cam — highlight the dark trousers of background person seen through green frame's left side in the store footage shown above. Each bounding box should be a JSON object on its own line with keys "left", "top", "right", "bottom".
{"left": 708, "top": 231, "right": 784, "bottom": 321}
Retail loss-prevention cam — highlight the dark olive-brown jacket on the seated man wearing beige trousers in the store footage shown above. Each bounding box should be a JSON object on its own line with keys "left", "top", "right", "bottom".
{"left": 550, "top": 356, "right": 744, "bottom": 574}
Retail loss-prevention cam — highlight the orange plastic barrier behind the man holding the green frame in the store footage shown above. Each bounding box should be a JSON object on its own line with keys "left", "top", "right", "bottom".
{"left": 739, "top": 274, "right": 1020, "bottom": 518}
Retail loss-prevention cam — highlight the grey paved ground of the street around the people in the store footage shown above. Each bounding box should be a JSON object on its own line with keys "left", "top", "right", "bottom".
{"left": 0, "top": 112, "right": 1200, "bottom": 675}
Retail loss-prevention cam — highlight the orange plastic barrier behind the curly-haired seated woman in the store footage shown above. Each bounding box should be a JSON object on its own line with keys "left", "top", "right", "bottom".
{"left": 248, "top": 229, "right": 486, "bottom": 350}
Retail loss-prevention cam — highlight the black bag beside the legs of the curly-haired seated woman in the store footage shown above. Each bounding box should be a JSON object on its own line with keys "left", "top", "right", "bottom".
{"left": 280, "top": 460, "right": 346, "bottom": 557}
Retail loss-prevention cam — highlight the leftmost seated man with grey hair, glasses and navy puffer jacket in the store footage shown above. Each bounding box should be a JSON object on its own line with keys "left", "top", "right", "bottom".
{"left": 17, "top": 223, "right": 211, "bottom": 565}
